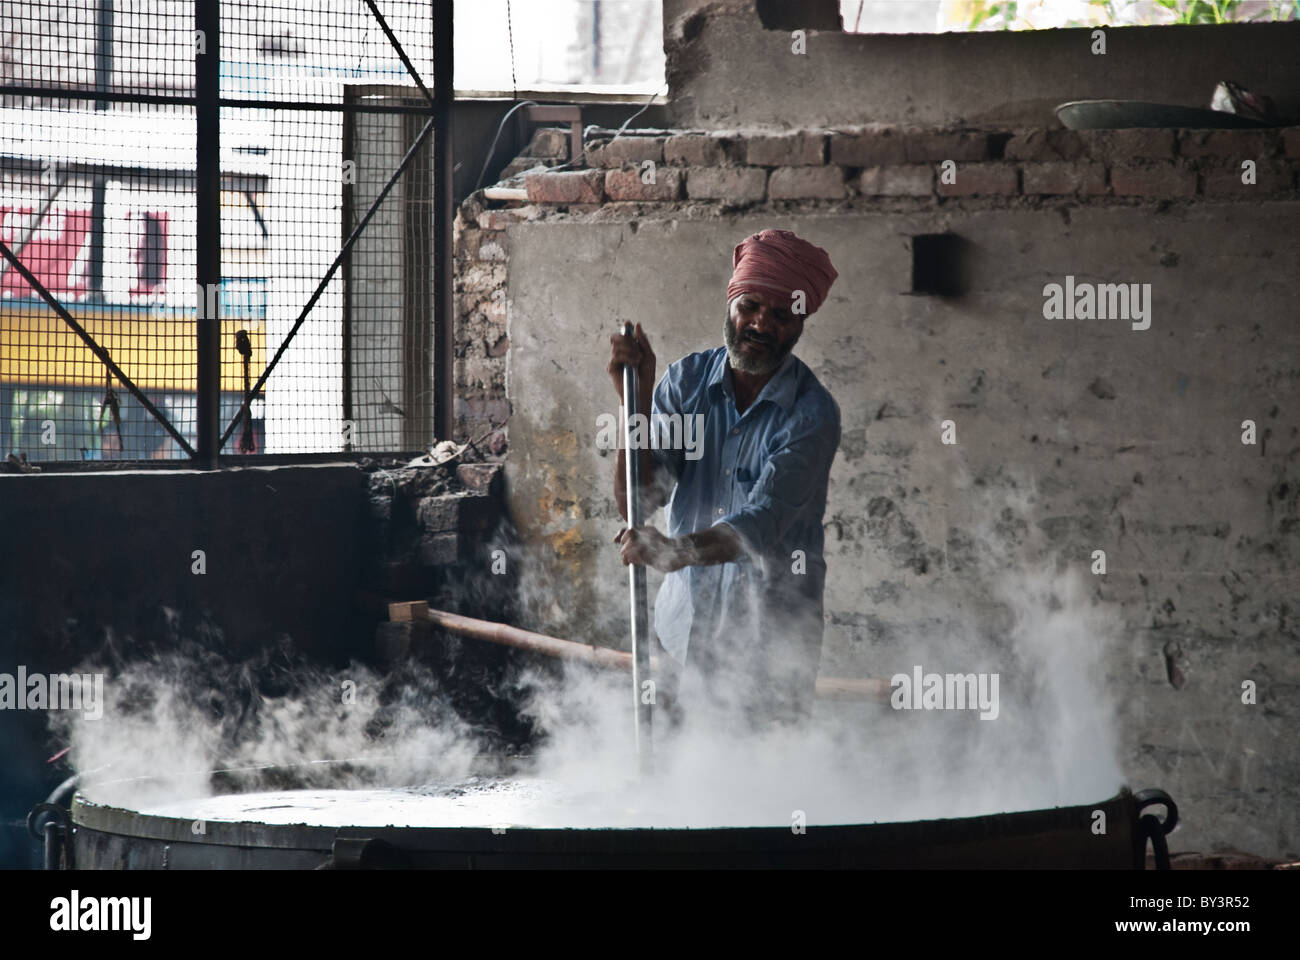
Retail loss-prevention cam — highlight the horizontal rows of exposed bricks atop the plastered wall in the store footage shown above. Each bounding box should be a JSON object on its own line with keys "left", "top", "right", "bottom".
{"left": 556, "top": 127, "right": 1300, "bottom": 207}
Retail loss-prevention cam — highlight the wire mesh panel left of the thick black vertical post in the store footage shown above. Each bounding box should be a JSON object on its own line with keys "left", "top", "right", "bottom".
{"left": 0, "top": 1, "right": 195, "bottom": 460}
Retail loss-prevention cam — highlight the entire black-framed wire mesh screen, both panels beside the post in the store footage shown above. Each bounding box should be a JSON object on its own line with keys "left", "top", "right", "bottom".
{"left": 0, "top": 0, "right": 434, "bottom": 462}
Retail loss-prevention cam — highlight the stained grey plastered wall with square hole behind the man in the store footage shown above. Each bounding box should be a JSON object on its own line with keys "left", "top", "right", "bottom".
{"left": 504, "top": 208, "right": 1300, "bottom": 856}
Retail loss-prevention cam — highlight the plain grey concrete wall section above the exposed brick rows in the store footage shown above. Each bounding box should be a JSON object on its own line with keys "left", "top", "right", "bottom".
{"left": 664, "top": 0, "right": 1300, "bottom": 129}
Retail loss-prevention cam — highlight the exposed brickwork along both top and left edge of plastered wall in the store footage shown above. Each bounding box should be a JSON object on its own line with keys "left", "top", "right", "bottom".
{"left": 455, "top": 125, "right": 1300, "bottom": 447}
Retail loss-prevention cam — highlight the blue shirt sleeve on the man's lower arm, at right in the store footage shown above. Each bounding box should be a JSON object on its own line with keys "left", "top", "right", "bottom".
{"left": 718, "top": 408, "right": 840, "bottom": 555}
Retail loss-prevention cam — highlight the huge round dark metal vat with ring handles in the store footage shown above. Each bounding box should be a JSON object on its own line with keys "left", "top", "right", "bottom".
{"left": 55, "top": 780, "right": 1177, "bottom": 869}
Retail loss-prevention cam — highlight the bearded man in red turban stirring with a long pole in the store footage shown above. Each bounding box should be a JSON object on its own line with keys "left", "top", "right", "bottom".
{"left": 607, "top": 230, "right": 840, "bottom": 728}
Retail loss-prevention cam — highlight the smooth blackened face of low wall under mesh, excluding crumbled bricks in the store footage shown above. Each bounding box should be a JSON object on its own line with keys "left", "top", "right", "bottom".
{"left": 0, "top": 464, "right": 374, "bottom": 866}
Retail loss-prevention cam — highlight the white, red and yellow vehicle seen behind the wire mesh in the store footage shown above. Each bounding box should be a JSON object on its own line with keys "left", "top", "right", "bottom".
{"left": 0, "top": 109, "right": 267, "bottom": 462}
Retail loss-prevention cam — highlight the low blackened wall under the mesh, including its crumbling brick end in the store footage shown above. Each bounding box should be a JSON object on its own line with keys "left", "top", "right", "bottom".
{"left": 0, "top": 460, "right": 527, "bottom": 866}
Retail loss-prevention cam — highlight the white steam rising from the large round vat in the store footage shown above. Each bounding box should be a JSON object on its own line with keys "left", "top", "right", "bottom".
{"left": 52, "top": 481, "right": 1122, "bottom": 827}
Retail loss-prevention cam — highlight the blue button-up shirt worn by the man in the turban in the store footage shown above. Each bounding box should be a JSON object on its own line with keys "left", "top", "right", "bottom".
{"left": 653, "top": 347, "right": 840, "bottom": 697}
